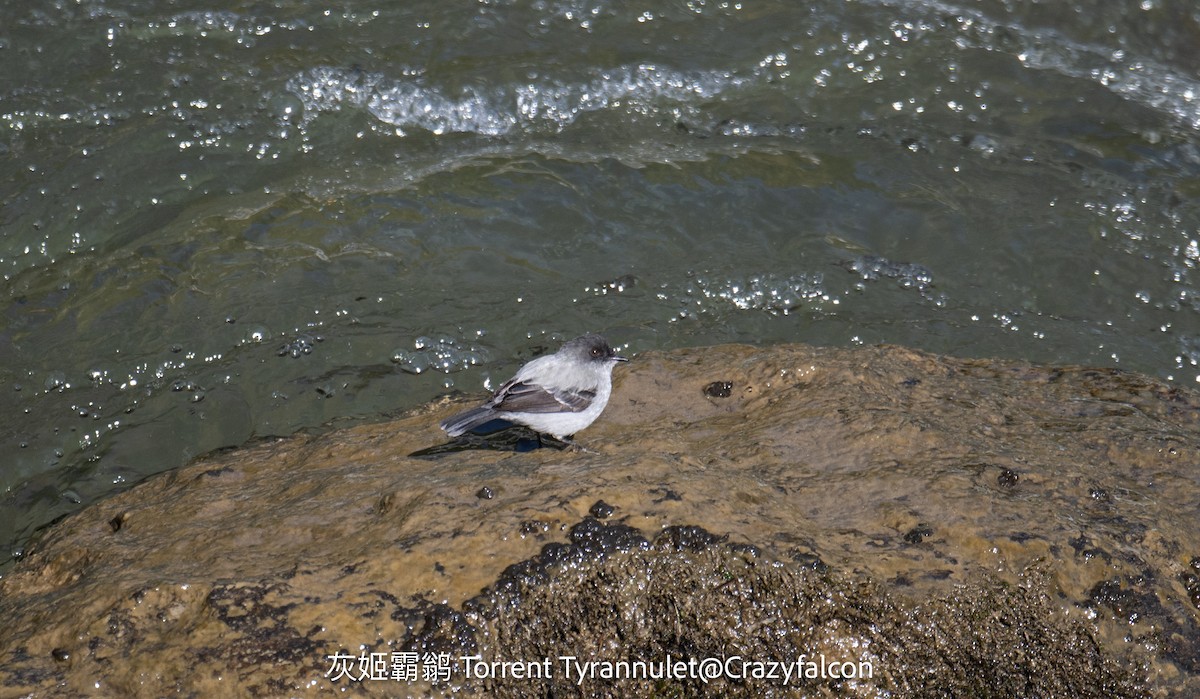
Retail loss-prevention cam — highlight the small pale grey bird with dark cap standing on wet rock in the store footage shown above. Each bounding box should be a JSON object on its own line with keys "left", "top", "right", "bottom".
{"left": 442, "top": 334, "right": 629, "bottom": 440}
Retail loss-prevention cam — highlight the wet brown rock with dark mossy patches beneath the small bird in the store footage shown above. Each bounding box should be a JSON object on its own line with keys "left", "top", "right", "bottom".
{"left": 0, "top": 346, "right": 1200, "bottom": 697}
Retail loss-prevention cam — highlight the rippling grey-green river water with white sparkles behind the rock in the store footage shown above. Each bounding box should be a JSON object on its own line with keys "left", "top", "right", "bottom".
{"left": 0, "top": 0, "right": 1200, "bottom": 564}
